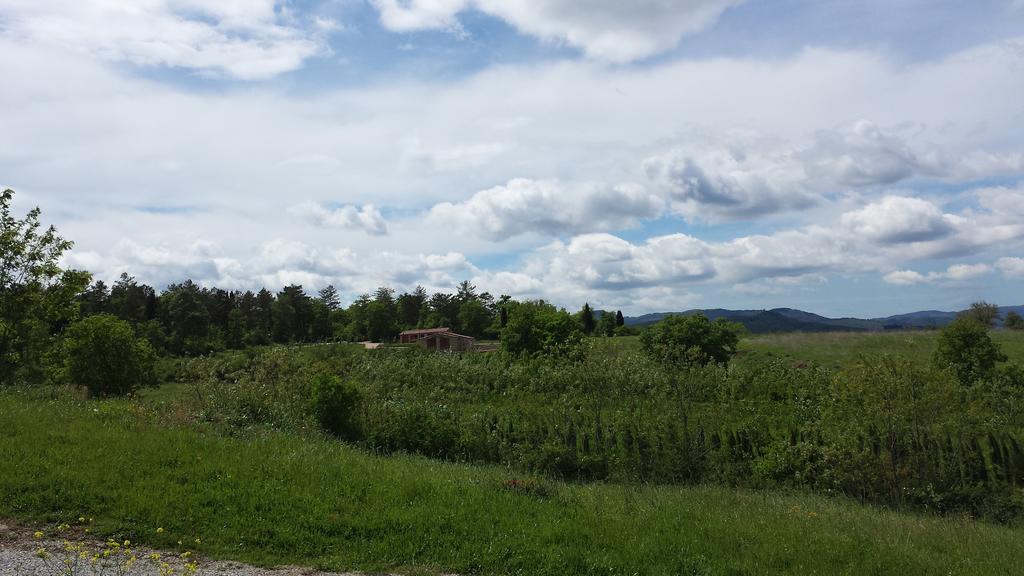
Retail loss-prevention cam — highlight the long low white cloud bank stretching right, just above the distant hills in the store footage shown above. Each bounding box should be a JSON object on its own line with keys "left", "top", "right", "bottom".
{"left": 493, "top": 186, "right": 1024, "bottom": 310}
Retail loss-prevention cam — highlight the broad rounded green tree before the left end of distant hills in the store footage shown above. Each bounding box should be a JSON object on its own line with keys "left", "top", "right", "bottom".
{"left": 640, "top": 314, "right": 743, "bottom": 366}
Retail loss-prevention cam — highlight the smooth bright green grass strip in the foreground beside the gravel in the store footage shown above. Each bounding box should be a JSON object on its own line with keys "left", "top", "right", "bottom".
{"left": 0, "top": 393, "right": 1024, "bottom": 576}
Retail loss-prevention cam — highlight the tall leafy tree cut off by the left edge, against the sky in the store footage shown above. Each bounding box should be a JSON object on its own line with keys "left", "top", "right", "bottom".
{"left": 0, "top": 190, "right": 90, "bottom": 384}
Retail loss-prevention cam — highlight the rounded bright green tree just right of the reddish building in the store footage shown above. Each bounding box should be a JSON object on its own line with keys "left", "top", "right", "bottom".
{"left": 501, "top": 300, "right": 583, "bottom": 356}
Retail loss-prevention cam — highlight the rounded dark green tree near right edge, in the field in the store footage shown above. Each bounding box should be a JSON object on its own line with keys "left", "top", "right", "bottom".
{"left": 932, "top": 316, "right": 1007, "bottom": 386}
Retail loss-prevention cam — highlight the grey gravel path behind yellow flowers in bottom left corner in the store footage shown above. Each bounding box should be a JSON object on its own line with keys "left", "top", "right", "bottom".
{"left": 0, "top": 524, "right": 359, "bottom": 576}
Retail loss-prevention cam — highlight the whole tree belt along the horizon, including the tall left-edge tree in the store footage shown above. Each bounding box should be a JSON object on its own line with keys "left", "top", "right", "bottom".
{"left": 0, "top": 190, "right": 628, "bottom": 381}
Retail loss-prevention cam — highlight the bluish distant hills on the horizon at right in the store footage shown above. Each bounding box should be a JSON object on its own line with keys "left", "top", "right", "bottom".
{"left": 626, "top": 305, "right": 1024, "bottom": 334}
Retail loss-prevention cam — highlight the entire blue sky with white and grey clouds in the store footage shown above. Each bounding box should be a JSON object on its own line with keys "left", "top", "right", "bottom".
{"left": 0, "top": 0, "right": 1024, "bottom": 317}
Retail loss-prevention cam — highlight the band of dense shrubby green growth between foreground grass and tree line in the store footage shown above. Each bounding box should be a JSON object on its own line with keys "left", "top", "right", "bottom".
{"left": 185, "top": 330, "right": 1024, "bottom": 520}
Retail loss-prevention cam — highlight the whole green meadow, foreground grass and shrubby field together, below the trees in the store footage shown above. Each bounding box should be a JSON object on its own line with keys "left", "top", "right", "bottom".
{"left": 0, "top": 332, "right": 1024, "bottom": 575}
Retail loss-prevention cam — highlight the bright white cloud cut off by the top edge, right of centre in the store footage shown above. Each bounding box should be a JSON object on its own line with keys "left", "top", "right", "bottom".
{"left": 373, "top": 0, "right": 742, "bottom": 63}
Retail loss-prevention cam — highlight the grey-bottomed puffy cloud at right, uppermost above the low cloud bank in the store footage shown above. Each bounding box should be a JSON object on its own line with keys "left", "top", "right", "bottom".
{"left": 643, "top": 120, "right": 1024, "bottom": 220}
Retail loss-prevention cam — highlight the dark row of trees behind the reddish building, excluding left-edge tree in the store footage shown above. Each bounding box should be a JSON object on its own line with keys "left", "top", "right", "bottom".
{"left": 76, "top": 274, "right": 625, "bottom": 356}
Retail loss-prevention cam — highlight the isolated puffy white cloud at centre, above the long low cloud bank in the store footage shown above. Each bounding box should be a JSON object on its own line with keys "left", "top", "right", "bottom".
{"left": 428, "top": 178, "right": 664, "bottom": 241}
